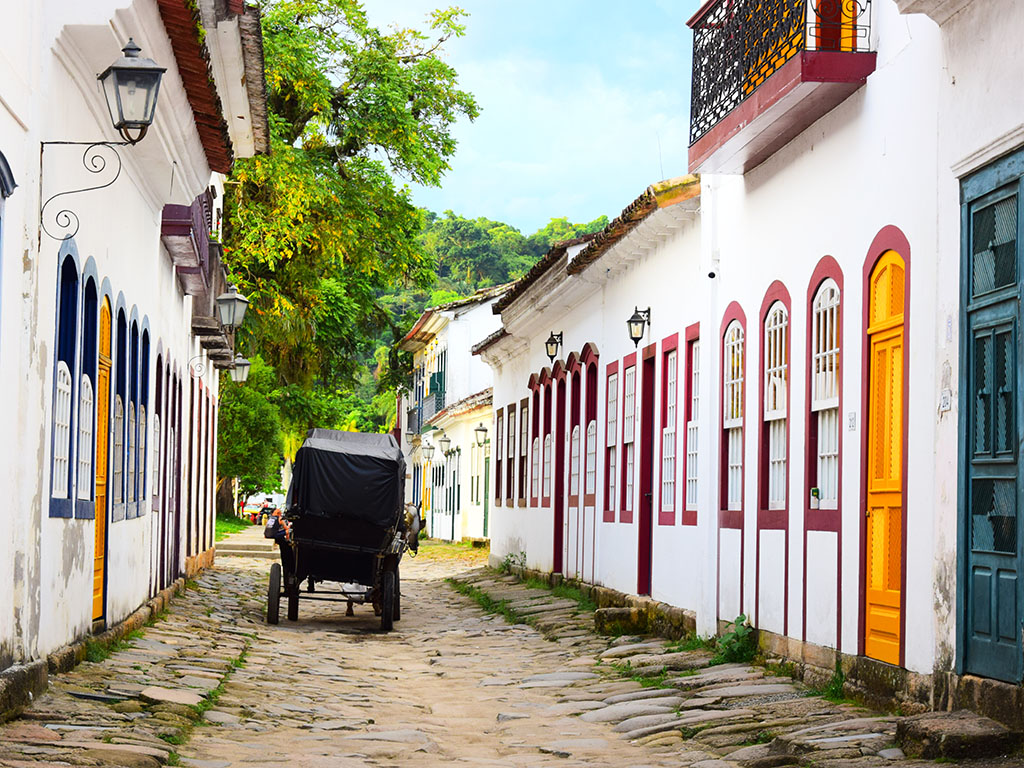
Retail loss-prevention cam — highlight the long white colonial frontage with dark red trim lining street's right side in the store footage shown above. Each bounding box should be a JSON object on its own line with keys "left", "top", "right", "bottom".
{"left": 475, "top": 0, "right": 1024, "bottom": 718}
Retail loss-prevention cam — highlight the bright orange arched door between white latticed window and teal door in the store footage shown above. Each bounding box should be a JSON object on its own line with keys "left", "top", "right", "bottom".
{"left": 864, "top": 251, "right": 904, "bottom": 665}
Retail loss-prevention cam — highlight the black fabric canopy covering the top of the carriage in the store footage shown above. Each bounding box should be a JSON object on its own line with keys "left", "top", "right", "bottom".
{"left": 285, "top": 429, "right": 406, "bottom": 527}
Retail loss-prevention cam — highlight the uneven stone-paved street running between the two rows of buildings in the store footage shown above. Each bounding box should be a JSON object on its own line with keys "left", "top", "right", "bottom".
{"left": 0, "top": 540, "right": 1024, "bottom": 768}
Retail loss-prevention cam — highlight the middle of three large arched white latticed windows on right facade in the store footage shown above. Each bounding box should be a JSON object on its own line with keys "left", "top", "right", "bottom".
{"left": 764, "top": 301, "right": 790, "bottom": 509}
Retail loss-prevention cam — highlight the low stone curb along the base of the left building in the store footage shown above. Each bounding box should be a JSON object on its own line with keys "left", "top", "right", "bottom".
{"left": 0, "top": 579, "right": 185, "bottom": 723}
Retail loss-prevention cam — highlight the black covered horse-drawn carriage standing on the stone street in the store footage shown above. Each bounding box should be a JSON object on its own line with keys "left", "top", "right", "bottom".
{"left": 266, "top": 429, "right": 420, "bottom": 631}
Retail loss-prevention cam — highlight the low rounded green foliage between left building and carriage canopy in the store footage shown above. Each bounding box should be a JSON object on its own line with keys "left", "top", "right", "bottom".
{"left": 217, "top": 356, "right": 284, "bottom": 498}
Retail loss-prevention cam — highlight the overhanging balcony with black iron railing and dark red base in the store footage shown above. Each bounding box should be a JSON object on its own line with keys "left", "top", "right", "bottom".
{"left": 688, "top": 0, "right": 876, "bottom": 173}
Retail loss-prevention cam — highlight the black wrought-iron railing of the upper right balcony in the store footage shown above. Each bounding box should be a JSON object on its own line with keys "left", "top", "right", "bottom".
{"left": 690, "top": 0, "right": 871, "bottom": 145}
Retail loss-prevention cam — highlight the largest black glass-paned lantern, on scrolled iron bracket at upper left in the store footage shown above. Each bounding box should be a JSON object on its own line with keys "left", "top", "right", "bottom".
{"left": 98, "top": 38, "right": 167, "bottom": 144}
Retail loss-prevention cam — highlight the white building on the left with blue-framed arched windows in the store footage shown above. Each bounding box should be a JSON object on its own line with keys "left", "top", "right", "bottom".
{"left": 0, "top": 0, "right": 267, "bottom": 667}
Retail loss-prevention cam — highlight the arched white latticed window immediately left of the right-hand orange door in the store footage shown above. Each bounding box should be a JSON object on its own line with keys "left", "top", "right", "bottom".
{"left": 811, "top": 278, "right": 840, "bottom": 509}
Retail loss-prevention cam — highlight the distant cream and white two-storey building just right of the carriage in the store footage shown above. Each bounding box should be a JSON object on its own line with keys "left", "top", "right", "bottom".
{"left": 396, "top": 286, "right": 508, "bottom": 541}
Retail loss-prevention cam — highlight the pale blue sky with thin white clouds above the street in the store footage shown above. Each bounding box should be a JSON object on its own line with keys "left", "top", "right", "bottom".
{"left": 365, "top": 0, "right": 699, "bottom": 234}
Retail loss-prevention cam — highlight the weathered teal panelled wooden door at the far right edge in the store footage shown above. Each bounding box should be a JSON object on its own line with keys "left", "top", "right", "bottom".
{"left": 958, "top": 158, "right": 1024, "bottom": 682}
